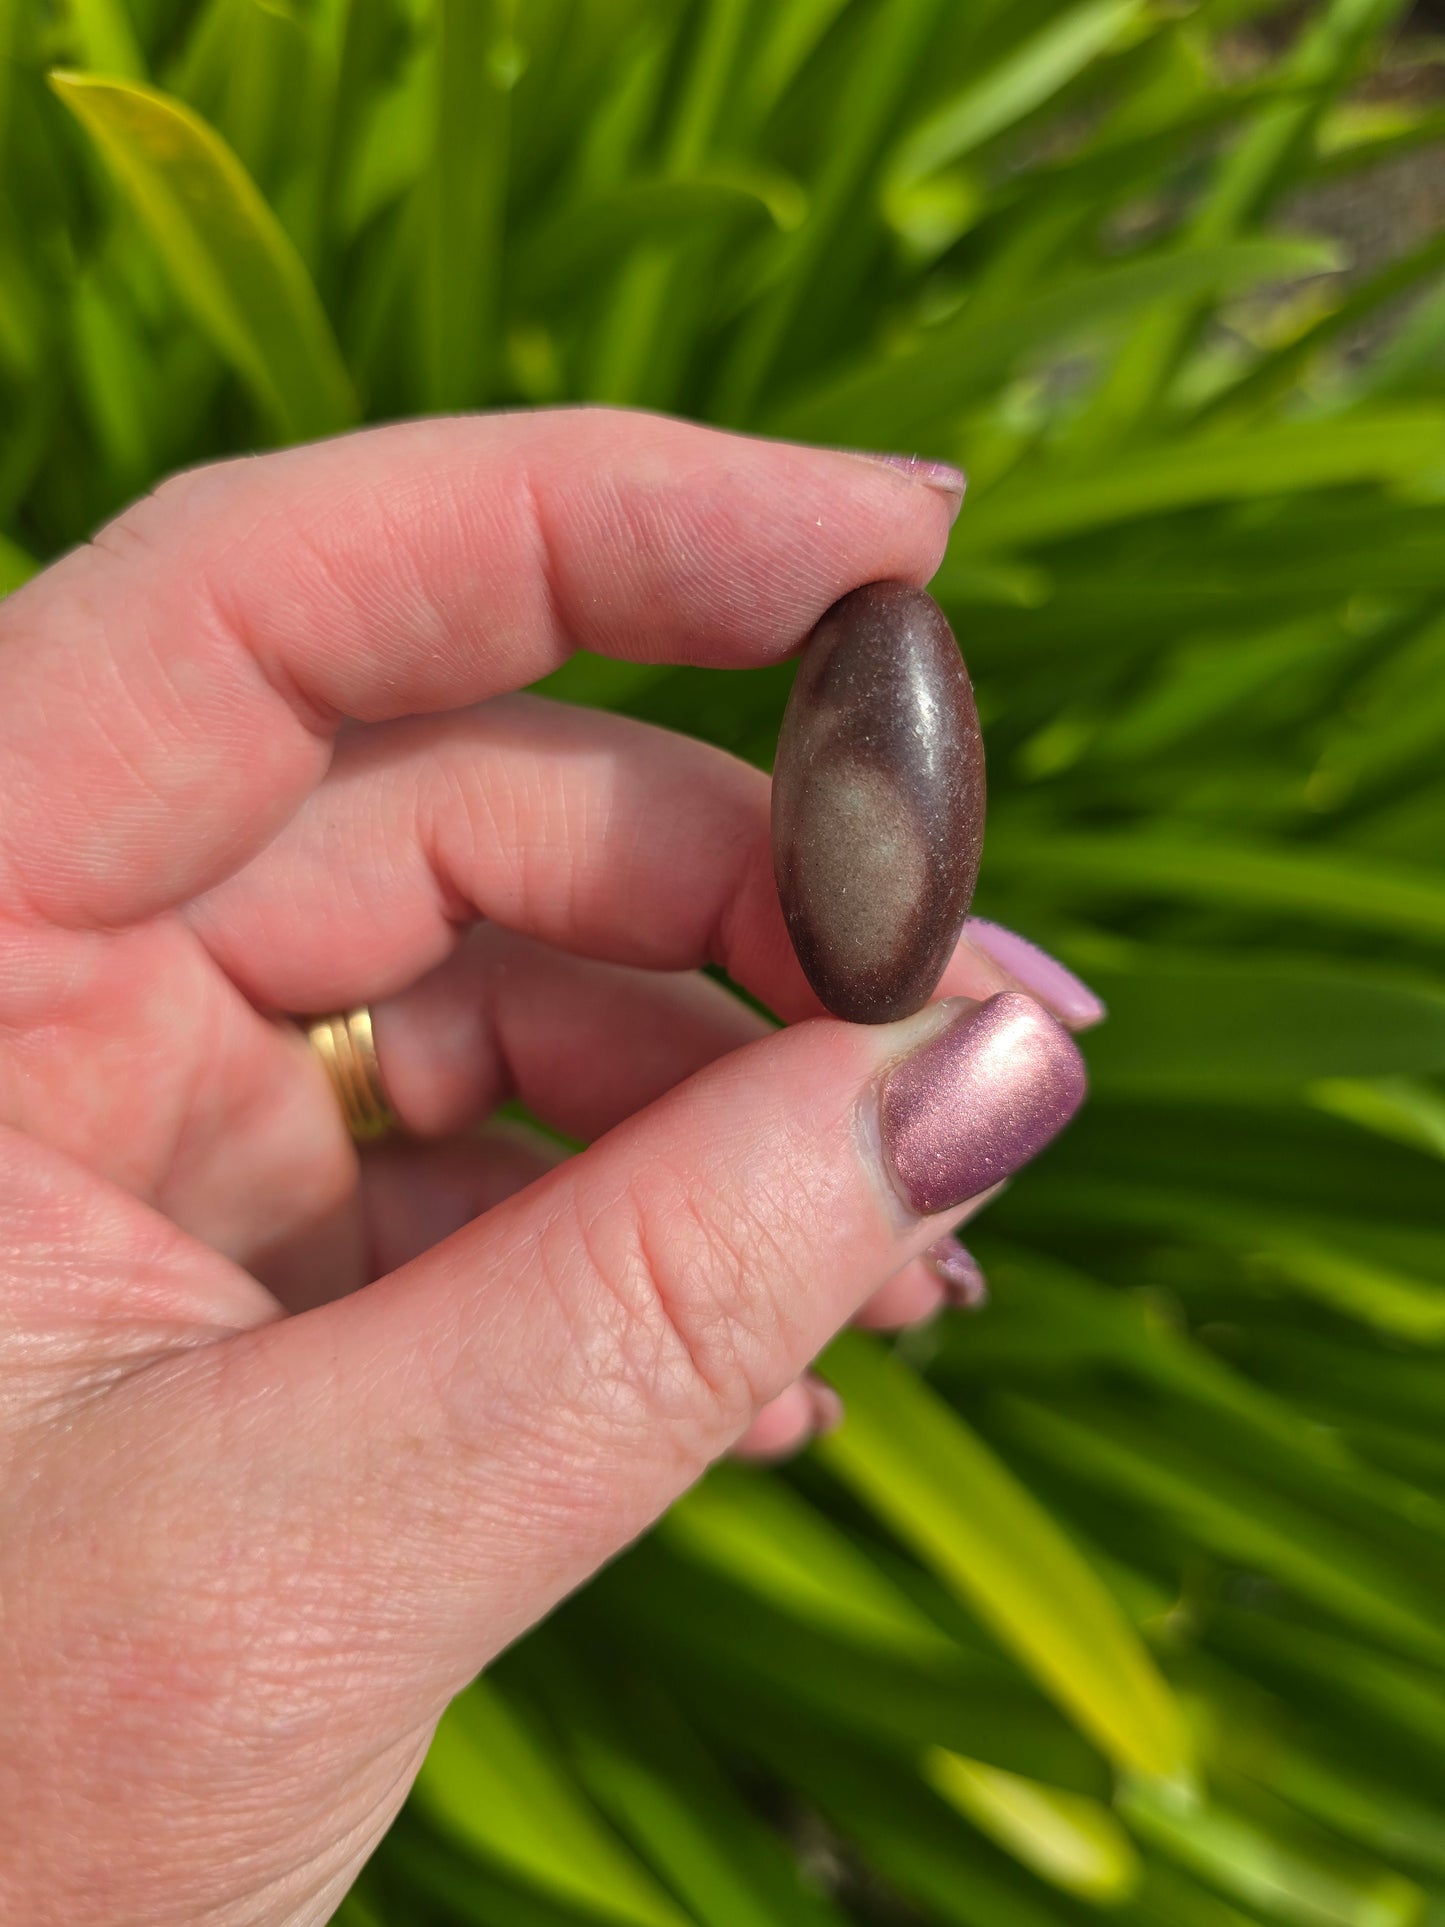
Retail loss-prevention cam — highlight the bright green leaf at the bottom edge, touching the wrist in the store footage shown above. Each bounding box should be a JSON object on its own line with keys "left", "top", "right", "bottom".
{"left": 416, "top": 1680, "right": 686, "bottom": 1927}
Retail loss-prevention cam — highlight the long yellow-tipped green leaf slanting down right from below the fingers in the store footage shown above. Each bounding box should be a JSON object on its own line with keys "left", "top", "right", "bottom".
{"left": 817, "top": 1333, "right": 1189, "bottom": 1775}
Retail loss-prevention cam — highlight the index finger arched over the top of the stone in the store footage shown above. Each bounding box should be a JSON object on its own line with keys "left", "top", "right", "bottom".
{"left": 0, "top": 409, "right": 958, "bottom": 927}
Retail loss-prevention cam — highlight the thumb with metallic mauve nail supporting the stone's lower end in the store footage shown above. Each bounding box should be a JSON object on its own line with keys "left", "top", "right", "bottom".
{"left": 246, "top": 994, "right": 1085, "bottom": 1696}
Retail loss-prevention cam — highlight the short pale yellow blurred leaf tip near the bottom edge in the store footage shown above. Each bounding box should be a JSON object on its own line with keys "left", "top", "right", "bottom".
{"left": 923, "top": 1746, "right": 1143, "bottom": 1906}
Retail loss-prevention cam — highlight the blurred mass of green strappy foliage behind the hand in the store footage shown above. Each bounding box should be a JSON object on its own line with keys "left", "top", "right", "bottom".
{"left": 0, "top": 0, "right": 1445, "bottom": 1927}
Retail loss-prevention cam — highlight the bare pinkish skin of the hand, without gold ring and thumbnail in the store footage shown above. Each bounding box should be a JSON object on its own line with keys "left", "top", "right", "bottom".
{"left": 0, "top": 410, "right": 1094, "bottom": 1927}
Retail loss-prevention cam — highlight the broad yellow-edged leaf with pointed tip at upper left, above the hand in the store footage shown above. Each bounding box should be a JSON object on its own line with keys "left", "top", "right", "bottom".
{"left": 50, "top": 73, "right": 356, "bottom": 439}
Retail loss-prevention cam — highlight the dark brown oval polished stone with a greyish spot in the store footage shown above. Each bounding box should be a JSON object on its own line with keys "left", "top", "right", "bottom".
{"left": 773, "top": 582, "right": 985, "bottom": 1023}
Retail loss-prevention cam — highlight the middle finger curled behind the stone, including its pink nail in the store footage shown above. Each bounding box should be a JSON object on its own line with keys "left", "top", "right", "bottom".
{"left": 189, "top": 698, "right": 1102, "bottom": 1041}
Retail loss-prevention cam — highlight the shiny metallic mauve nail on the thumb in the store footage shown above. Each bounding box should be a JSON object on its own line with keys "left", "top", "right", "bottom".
{"left": 879, "top": 990, "right": 1085, "bottom": 1218}
